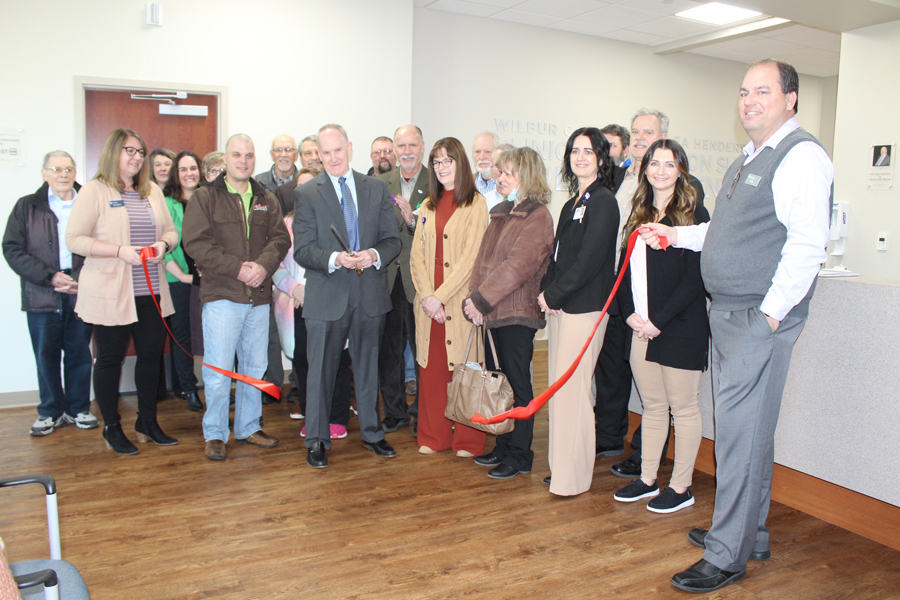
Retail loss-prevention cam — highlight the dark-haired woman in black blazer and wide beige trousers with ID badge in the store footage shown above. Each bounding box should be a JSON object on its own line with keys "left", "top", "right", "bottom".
{"left": 538, "top": 127, "right": 619, "bottom": 496}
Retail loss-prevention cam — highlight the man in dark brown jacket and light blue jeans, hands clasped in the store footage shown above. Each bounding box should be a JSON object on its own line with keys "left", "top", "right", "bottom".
{"left": 182, "top": 134, "right": 291, "bottom": 460}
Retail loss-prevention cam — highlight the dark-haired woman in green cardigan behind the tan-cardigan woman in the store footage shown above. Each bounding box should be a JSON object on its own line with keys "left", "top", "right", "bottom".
{"left": 163, "top": 152, "right": 203, "bottom": 412}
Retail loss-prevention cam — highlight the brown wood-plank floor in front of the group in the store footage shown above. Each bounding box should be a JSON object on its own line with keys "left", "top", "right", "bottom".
{"left": 0, "top": 353, "right": 900, "bottom": 600}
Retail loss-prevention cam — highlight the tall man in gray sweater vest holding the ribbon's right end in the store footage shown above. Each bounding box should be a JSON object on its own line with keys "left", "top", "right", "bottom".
{"left": 643, "top": 59, "right": 834, "bottom": 592}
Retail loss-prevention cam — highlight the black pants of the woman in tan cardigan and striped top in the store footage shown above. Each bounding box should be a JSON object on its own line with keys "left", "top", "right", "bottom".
{"left": 94, "top": 296, "right": 166, "bottom": 425}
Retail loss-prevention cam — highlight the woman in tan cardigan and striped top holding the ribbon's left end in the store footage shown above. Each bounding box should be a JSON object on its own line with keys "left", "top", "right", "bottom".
{"left": 66, "top": 129, "right": 178, "bottom": 454}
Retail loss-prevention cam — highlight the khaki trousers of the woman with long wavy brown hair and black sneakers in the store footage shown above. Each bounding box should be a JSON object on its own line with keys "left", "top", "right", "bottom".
{"left": 631, "top": 332, "right": 703, "bottom": 487}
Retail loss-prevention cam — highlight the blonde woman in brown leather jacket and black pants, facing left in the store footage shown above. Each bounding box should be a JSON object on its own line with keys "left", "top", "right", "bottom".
{"left": 463, "top": 148, "right": 553, "bottom": 479}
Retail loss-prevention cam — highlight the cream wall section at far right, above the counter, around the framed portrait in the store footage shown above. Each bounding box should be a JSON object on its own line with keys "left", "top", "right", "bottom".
{"left": 829, "top": 21, "right": 900, "bottom": 279}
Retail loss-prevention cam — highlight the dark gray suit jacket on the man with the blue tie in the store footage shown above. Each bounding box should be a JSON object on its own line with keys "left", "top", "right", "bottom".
{"left": 294, "top": 171, "right": 400, "bottom": 321}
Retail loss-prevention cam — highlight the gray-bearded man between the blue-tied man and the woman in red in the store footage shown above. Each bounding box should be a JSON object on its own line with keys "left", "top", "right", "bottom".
{"left": 378, "top": 125, "right": 428, "bottom": 433}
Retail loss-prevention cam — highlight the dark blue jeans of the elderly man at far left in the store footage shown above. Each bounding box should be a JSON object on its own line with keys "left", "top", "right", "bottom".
{"left": 27, "top": 294, "right": 93, "bottom": 419}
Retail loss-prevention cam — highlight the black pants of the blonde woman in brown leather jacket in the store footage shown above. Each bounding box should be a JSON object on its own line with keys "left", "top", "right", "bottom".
{"left": 484, "top": 325, "right": 537, "bottom": 473}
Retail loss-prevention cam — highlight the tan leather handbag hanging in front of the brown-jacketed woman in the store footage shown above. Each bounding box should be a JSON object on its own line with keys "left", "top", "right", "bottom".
{"left": 444, "top": 325, "right": 515, "bottom": 435}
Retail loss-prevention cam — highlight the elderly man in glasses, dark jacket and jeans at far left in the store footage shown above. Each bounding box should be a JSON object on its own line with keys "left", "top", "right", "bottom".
{"left": 3, "top": 150, "right": 98, "bottom": 436}
